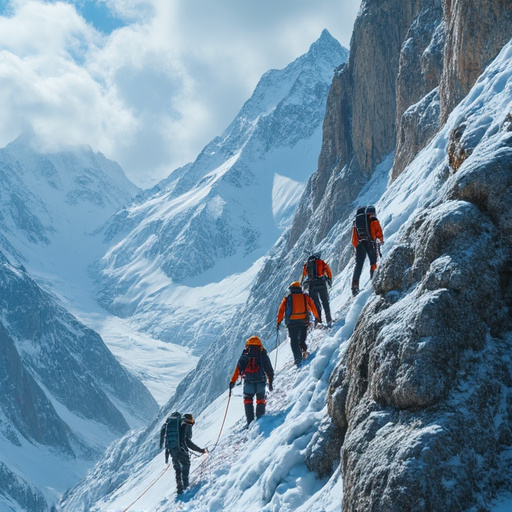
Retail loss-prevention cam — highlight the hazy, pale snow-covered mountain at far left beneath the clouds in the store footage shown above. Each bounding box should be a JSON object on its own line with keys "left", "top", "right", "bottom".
{"left": 0, "top": 134, "right": 139, "bottom": 298}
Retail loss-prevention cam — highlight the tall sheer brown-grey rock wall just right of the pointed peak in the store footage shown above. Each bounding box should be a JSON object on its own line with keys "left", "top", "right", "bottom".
{"left": 288, "top": 0, "right": 421, "bottom": 249}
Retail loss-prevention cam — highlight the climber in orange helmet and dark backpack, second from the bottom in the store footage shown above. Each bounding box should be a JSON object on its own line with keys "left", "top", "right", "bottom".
{"left": 229, "top": 336, "right": 274, "bottom": 425}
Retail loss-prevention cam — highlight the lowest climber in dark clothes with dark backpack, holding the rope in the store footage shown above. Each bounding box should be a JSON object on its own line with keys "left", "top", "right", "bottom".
{"left": 160, "top": 412, "right": 208, "bottom": 495}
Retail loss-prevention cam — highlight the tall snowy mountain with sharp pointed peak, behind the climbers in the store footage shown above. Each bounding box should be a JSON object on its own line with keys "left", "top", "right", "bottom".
{"left": 92, "top": 31, "right": 347, "bottom": 352}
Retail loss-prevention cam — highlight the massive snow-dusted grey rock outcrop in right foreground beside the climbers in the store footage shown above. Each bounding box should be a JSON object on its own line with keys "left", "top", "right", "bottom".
{"left": 320, "top": 27, "right": 512, "bottom": 512}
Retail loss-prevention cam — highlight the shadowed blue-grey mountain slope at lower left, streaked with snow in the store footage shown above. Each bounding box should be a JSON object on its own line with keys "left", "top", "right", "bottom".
{"left": 0, "top": 253, "right": 157, "bottom": 511}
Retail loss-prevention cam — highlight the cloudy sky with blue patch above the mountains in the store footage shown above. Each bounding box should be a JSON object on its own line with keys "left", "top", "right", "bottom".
{"left": 0, "top": 0, "right": 360, "bottom": 188}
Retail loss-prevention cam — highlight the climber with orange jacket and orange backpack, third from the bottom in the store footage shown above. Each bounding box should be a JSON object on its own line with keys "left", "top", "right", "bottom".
{"left": 277, "top": 281, "right": 320, "bottom": 366}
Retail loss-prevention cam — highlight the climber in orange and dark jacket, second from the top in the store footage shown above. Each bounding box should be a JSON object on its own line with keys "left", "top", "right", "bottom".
{"left": 302, "top": 253, "right": 332, "bottom": 327}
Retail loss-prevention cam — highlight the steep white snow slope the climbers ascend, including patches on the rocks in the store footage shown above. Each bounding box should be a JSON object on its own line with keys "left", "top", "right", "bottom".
{"left": 57, "top": 38, "right": 512, "bottom": 511}
